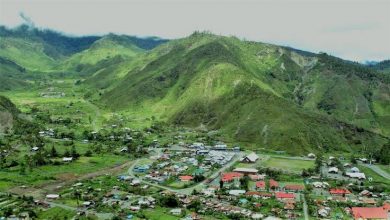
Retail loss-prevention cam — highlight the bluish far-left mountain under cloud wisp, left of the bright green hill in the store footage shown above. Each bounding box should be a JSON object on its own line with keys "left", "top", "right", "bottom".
{"left": 0, "top": 25, "right": 100, "bottom": 69}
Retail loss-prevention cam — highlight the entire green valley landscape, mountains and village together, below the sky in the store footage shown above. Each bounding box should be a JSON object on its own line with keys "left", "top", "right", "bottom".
{"left": 0, "top": 26, "right": 390, "bottom": 219}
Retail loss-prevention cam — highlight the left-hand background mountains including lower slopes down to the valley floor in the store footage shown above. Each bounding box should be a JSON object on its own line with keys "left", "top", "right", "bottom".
{"left": 0, "top": 25, "right": 167, "bottom": 91}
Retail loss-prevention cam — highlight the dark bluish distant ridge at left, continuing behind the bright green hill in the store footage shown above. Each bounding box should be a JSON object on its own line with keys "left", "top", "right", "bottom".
{"left": 0, "top": 25, "right": 166, "bottom": 71}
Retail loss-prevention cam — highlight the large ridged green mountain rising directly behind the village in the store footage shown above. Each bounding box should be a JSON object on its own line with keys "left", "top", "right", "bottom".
{"left": 101, "top": 33, "right": 390, "bottom": 153}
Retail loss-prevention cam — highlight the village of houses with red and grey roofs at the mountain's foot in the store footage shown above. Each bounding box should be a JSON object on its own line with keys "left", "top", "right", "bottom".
{"left": 0, "top": 122, "right": 390, "bottom": 220}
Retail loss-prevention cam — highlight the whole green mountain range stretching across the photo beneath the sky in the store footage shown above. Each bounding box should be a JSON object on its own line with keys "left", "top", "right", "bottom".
{"left": 0, "top": 26, "right": 390, "bottom": 154}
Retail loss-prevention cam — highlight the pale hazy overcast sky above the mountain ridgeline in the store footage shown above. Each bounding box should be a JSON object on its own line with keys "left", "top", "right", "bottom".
{"left": 0, "top": 0, "right": 390, "bottom": 61}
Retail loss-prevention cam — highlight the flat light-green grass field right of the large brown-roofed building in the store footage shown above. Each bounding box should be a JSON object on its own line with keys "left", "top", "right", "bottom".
{"left": 261, "top": 157, "right": 314, "bottom": 172}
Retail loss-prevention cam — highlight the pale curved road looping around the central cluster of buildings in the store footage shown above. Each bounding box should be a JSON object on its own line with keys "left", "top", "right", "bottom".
{"left": 128, "top": 152, "right": 244, "bottom": 195}
